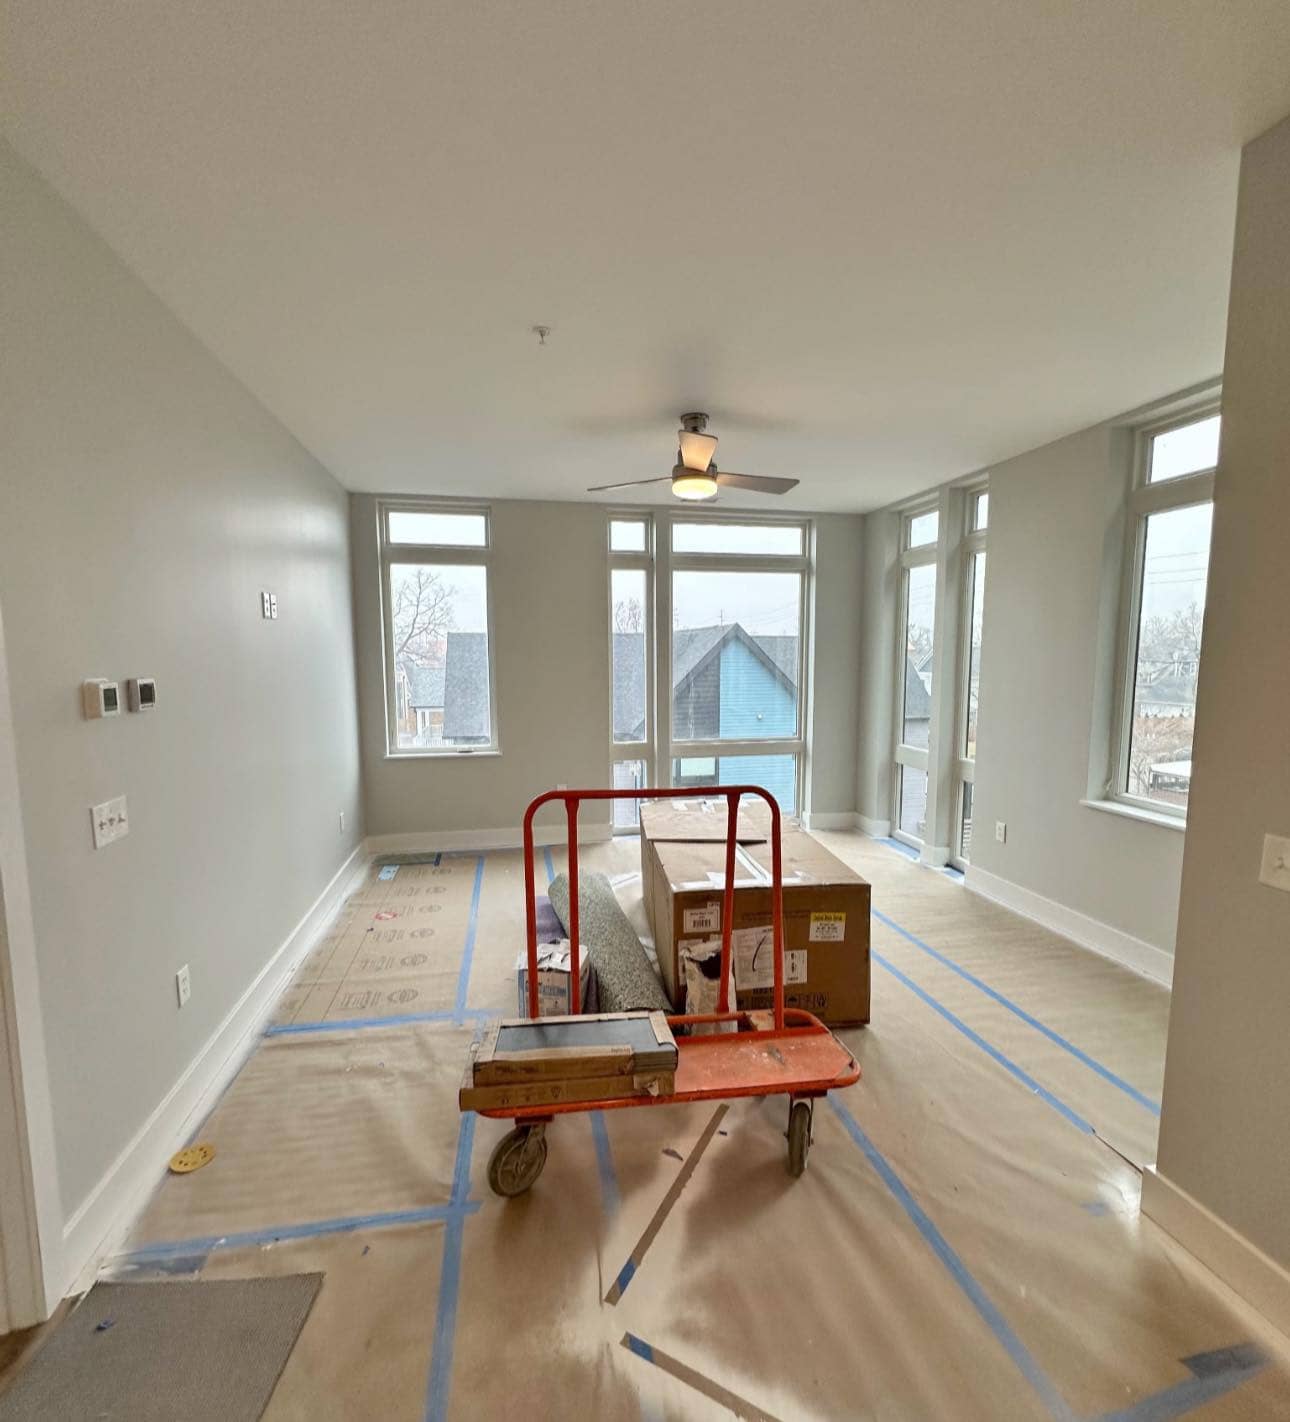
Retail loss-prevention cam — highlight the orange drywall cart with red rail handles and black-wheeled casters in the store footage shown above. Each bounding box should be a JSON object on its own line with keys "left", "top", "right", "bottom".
{"left": 469, "top": 785, "right": 860, "bottom": 1196}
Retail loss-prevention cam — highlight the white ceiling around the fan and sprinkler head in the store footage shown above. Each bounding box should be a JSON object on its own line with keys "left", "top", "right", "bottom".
{"left": 3, "top": 0, "right": 1290, "bottom": 509}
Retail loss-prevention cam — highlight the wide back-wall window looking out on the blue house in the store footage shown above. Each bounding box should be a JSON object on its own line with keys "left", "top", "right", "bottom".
{"left": 668, "top": 519, "right": 808, "bottom": 813}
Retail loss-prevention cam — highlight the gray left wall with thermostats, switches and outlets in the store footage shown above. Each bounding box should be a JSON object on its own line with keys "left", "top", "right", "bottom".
{"left": 0, "top": 145, "right": 361, "bottom": 1213}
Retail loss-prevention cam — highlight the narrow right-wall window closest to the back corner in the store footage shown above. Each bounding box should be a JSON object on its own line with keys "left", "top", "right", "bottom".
{"left": 895, "top": 509, "right": 940, "bottom": 845}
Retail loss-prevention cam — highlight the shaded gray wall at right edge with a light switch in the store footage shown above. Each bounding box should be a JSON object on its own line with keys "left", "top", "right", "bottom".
{"left": 1159, "top": 119, "right": 1290, "bottom": 1267}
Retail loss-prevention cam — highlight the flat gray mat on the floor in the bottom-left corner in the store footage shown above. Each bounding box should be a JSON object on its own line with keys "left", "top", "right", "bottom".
{"left": 0, "top": 1274, "right": 323, "bottom": 1422}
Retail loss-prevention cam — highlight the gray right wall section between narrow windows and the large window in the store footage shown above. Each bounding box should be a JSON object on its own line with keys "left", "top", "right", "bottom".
{"left": 973, "top": 424, "right": 1189, "bottom": 953}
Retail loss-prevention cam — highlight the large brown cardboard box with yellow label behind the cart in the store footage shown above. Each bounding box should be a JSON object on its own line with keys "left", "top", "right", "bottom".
{"left": 640, "top": 801, "right": 870, "bottom": 1027}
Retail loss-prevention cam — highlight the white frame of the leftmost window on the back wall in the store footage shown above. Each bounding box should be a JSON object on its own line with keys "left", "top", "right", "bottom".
{"left": 377, "top": 498, "right": 502, "bottom": 761}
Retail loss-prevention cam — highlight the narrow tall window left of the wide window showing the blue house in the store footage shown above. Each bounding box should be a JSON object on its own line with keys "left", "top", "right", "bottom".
{"left": 609, "top": 516, "right": 654, "bottom": 830}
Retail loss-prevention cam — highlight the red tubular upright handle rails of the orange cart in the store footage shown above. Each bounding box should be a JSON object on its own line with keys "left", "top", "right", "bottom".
{"left": 523, "top": 785, "right": 784, "bottom": 1031}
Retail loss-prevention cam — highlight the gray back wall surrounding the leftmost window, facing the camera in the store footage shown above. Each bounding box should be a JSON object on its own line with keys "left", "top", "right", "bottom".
{"left": 350, "top": 495, "right": 862, "bottom": 838}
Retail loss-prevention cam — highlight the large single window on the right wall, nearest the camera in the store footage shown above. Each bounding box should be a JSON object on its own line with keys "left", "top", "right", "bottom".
{"left": 1111, "top": 408, "right": 1220, "bottom": 818}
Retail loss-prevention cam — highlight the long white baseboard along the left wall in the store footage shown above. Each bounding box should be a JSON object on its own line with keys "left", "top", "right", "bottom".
{"left": 63, "top": 845, "right": 368, "bottom": 1294}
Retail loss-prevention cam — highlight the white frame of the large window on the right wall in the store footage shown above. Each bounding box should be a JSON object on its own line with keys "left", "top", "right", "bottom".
{"left": 1102, "top": 392, "right": 1222, "bottom": 826}
